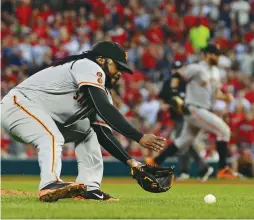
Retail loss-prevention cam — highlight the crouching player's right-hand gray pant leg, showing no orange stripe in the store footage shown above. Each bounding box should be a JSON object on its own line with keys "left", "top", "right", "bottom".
{"left": 59, "top": 119, "right": 103, "bottom": 191}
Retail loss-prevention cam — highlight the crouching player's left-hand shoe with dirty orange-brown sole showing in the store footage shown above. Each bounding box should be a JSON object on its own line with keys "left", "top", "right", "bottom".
{"left": 39, "top": 181, "right": 86, "bottom": 202}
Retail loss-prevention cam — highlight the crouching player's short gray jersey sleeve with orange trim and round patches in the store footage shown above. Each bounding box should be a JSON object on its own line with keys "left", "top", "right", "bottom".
{"left": 70, "top": 60, "right": 106, "bottom": 90}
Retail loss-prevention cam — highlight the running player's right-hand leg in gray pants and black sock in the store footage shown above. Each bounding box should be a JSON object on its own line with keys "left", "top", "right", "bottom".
{"left": 190, "top": 107, "right": 230, "bottom": 174}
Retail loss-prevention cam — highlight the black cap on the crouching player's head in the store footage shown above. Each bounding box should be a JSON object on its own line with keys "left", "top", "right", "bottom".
{"left": 92, "top": 41, "right": 133, "bottom": 74}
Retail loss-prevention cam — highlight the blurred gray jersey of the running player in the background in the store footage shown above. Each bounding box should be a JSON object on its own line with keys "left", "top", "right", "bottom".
{"left": 180, "top": 61, "right": 220, "bottom": 109}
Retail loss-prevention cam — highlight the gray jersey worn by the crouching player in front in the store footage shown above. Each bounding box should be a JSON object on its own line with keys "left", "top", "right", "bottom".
{"left": 17, "top": 59, "right": 106, "bottom": 126}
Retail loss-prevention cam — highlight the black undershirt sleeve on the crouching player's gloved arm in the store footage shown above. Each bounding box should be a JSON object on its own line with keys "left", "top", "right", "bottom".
{"left": 92, "top": 125, "right": 132, "bottom": 165}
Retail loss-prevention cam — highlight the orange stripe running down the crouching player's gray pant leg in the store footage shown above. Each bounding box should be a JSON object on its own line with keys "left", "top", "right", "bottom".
{"left": 13, "top": 96, "right": 55, "bottom": 173}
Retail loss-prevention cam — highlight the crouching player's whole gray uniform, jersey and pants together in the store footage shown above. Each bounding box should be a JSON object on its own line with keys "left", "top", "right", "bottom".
{"left": 1, "top": 59, "right": 111, "bottom": 190}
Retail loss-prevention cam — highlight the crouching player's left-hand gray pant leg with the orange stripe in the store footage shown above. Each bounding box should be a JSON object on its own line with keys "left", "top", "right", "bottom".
{"left": 1, "top": 93, "right": 64, "bottom": 189}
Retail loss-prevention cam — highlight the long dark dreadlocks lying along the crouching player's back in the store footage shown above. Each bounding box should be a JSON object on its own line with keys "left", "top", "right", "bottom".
{"left": 51, "top": 50, "right": 99, "bottom": 67}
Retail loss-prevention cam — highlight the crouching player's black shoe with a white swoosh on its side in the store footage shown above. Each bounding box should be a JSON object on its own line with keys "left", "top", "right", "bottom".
{"left": 74, "top": 189, "right": 120, "bottom": 202}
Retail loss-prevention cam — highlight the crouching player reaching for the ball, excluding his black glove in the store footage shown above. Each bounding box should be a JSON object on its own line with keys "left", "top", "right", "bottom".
{"left": 1, "top": 42, "right": 165, "bottom": 202}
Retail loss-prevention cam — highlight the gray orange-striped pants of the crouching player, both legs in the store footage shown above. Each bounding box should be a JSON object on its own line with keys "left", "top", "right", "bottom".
{"left": 1, "top": 89, "right": 103, "bottom": 190}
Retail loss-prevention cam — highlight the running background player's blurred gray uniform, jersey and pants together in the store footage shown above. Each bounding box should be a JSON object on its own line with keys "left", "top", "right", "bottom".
{"left": 175, "top": 61, "right": 230, "bottom": 149}
